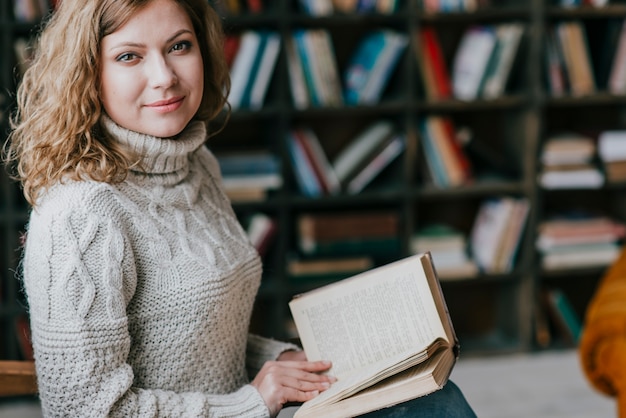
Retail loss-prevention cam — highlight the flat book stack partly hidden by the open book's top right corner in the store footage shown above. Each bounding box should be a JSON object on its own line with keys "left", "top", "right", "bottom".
{"left": 411, "top": 224, "right": 478, "bottom": 280}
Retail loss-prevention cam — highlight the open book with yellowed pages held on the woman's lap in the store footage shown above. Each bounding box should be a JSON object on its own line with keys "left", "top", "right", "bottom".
{"left": 289, "top": 253, "right": 459, "bottom": 418}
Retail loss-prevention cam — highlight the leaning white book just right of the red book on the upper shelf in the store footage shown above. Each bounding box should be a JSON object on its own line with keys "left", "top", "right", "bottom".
{"left": 452, "top": 26, "right": 496, "bottom": 100}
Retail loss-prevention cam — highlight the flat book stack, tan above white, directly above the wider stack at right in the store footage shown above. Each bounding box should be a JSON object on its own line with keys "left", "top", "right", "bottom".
{"left": 539, "top": 133, "right": 604, "bottom": 189}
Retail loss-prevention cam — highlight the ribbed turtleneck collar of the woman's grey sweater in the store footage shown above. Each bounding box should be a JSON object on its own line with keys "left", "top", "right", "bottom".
{"left": 102, "top": 115, "right": 206, "bottom": 179}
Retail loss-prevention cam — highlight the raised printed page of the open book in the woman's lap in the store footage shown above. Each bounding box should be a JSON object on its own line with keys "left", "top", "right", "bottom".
{"left": 290, "top": 255, "right": 448, "bottom": 379}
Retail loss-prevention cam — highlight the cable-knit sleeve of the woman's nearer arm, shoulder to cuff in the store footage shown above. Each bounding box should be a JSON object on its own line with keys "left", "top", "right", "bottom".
{"left": 23, "top": 198, "right": 269, "bottom": 417}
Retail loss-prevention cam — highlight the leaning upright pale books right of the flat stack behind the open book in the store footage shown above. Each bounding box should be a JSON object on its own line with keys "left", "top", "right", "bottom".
{"left": 470, "top": 196, "right": 529, "bottom": 274}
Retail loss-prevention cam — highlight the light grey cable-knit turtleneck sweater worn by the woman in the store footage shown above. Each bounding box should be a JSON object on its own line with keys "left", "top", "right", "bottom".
{"left": 23, "top": 118, "right": 294, "bottom": 417}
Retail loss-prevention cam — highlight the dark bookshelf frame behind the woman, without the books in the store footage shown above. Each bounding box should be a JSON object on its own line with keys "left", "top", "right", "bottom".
{"left": 0, "top": 0, "right": 626, "bottom": 359}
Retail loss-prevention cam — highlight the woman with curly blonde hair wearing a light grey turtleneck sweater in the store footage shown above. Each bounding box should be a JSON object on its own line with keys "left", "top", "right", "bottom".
{"left": 7, "top": 0, "right": 472, "bottom": 417}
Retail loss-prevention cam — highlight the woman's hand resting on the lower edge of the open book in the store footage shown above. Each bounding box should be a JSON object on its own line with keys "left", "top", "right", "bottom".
{"left": 252, "top": 351, "right": 336, "bottom": 417}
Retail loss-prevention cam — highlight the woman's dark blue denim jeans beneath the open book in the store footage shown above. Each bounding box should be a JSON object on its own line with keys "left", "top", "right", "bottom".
{"left": 278, "top": 381, "right": 476, "bottom": 418}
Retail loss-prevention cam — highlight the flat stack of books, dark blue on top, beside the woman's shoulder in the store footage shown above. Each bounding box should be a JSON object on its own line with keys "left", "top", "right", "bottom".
{"left": 216, "top": 151, "right": 283, "bottom": 202}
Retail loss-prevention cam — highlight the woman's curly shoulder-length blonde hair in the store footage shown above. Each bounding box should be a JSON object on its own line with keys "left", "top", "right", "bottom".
{"left": 4, "top": 0, "right": 230, "bottom": 206}
